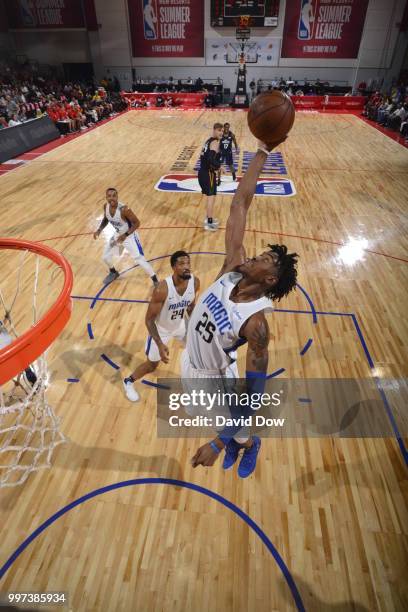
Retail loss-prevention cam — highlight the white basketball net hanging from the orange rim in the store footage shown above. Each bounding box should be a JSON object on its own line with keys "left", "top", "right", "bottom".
{"left": 0, "top": 251, "right": 66, "bottom": 488}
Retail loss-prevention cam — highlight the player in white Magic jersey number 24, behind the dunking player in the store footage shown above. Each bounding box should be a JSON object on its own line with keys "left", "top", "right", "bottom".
{"left": 123, "top": 251, "right": 200, "bottom": 402}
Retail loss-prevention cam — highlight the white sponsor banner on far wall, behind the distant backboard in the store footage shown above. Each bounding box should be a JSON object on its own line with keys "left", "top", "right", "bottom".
{"left": 205, "top": 36, "right": 280, "bottom": 70}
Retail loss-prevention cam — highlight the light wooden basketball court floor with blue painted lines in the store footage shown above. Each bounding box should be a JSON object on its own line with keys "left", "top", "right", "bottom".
{"left": 0, "top": 111, "right": 408, "bottom": 612}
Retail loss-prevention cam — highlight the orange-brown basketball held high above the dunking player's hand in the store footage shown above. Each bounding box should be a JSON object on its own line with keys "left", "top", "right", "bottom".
{"left": 248, "top": 89, "right": 295, "bottom": 144}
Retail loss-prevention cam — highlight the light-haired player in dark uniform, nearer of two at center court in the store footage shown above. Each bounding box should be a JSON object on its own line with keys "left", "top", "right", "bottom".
{"left": 198, "top": 123, "right": 223, "bottom": 232}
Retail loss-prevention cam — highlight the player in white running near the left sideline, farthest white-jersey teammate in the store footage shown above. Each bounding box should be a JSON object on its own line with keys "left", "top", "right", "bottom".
{"left": 93, "top": 187, "right": 159, "bottom": 287}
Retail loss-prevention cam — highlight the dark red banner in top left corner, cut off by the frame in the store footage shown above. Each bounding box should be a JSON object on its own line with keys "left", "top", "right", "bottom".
{"left": 6, "top": 0, "right": 85, "bottom": 29}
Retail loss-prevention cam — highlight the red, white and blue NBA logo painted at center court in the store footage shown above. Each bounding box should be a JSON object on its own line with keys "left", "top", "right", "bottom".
{"left": 154, "top": 174, "right": 296, "bottom": 197}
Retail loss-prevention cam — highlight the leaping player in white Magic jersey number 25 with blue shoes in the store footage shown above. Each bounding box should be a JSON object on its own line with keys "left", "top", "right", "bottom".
{"left": 181, "top": 139, "right": 298, "bottom": 478}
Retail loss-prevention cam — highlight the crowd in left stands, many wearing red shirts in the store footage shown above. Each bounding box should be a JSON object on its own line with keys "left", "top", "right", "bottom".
{"left": 0, "top": 70, "right": 127, "bottom": 134}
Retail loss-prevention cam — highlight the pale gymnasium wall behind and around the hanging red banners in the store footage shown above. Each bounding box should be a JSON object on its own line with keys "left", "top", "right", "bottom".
{"left": 5, "top": 0, "right": 407, "bottom": 89}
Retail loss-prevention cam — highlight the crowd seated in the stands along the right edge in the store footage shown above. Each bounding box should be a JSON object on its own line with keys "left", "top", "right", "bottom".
{"left": 363, "top": 84, "right": 408, "bottom": 142}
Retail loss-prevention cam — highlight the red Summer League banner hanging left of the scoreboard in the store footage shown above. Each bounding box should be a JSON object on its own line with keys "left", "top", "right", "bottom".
{"left": 128, "top": 0, "right": 204, "bottom": 57}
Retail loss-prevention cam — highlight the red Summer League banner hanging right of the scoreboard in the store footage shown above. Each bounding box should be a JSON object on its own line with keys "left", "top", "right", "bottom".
{"left": 281, "top": 0, "right": 368, "bottom": 59}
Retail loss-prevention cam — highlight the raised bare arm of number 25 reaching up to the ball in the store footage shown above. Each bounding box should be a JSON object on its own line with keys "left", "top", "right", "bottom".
{"left": 222, "top": 136, "right": 286, "bottom": 273}
